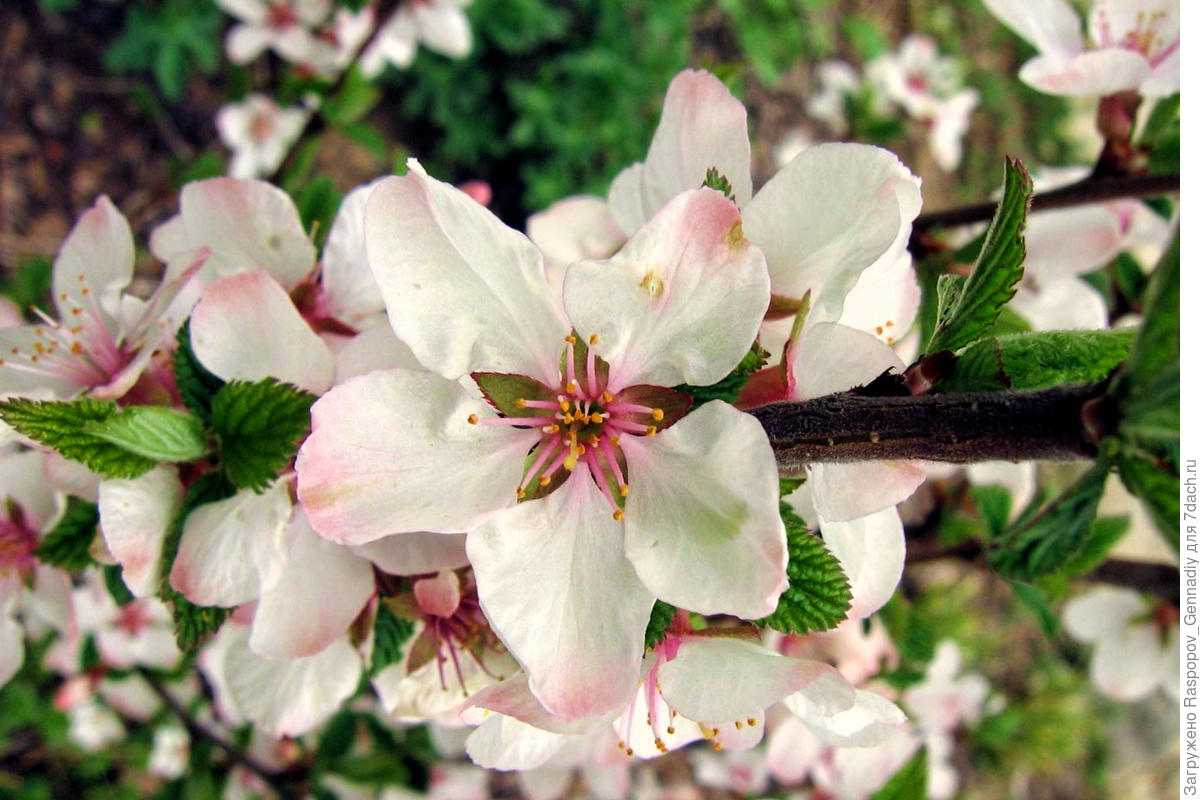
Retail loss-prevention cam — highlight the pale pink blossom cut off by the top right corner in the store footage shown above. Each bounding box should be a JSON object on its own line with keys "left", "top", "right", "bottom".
{"left": 984, "top": 0, "right": 1180, "bottom": 97}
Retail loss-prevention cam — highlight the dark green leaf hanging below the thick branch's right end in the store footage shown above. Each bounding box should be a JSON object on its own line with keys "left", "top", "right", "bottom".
{"left": 989, "top": 458, "right": 1109, "bottom": 579}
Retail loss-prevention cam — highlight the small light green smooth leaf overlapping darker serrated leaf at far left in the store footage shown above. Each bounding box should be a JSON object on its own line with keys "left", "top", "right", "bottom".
{"left": 84, "top": 405, "right": 208, "bottom": 462}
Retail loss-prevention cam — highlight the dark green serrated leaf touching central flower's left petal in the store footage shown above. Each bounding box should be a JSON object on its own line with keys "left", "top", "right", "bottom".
{"left": 212, "top": 378, "right": 317, "bottom": 492}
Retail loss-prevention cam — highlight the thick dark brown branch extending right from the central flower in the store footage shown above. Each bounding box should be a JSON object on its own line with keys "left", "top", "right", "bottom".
{"left": 750, "top": 384, "right": 1104, "bottom": 473}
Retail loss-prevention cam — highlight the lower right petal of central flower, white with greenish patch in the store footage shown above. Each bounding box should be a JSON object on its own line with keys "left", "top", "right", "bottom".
{"left": 619, "top": 401, "right": 787, "bottom": 618}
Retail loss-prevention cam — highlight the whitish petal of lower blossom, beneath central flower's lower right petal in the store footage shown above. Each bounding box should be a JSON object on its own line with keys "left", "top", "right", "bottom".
{"left": 659, "top": 637, "right": 854, "bottom": 722}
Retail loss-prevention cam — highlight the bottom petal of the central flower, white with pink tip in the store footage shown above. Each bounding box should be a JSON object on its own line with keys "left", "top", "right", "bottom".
{"left": 467, "top": 469, "right": 654, "bottom": 720}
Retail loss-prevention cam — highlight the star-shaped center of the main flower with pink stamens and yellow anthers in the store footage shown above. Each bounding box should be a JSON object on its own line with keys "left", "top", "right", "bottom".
{"left": 467, "top": 333, "right": 691, "bottom": 522}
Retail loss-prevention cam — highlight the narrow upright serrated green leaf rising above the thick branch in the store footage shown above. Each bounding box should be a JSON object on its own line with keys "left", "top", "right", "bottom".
{"left": 926, "top": 158, "right": 1033, "bottom": 353}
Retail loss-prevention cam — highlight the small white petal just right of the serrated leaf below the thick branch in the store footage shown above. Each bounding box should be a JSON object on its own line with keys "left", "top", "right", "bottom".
{"left": 821, "top": 506, "right": 905, "bottom": 619}
